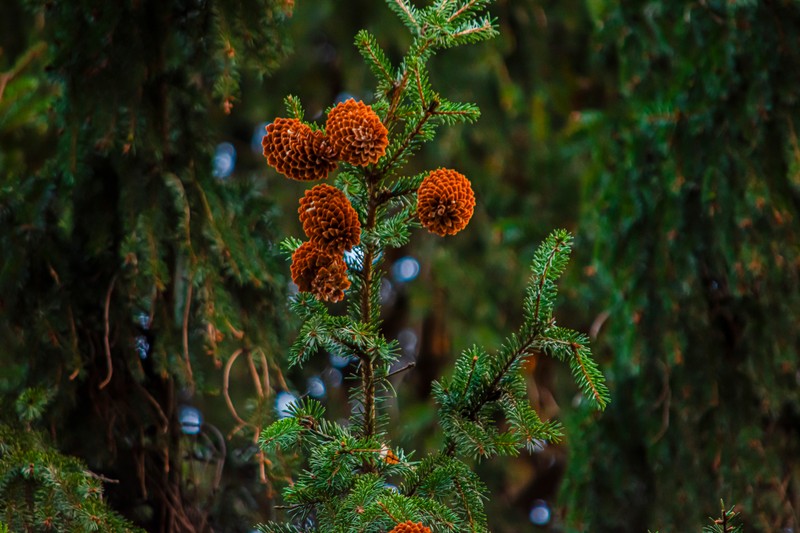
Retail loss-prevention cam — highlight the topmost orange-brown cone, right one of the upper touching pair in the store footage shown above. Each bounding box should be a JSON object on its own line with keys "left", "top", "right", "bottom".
{"left": 325, "top": 98, "right": 389, "bottom": 167}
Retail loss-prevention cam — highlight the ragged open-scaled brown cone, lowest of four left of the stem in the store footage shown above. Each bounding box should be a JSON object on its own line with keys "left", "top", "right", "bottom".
{"left": 291, "top": 242, "right": 350, "bottom": 302}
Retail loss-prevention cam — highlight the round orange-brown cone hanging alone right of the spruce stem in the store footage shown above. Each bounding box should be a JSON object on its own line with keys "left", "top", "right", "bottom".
{"left": 417, "top": 168, "right": 475, "bottom": 237}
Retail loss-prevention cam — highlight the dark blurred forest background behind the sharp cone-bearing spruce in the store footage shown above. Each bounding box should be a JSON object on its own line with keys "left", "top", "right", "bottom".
{"left": 0, "top": 0, "right": 800, "bottom": 532}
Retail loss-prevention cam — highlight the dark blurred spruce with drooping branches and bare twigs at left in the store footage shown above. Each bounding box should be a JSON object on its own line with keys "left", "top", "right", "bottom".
{"left": 0, "top": 0, "right": 292, "bottom": 531}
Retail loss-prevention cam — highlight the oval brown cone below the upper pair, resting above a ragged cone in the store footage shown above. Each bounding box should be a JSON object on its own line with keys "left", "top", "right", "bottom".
{"left": 297, "top": 183, "right": 361, "bottom": 253}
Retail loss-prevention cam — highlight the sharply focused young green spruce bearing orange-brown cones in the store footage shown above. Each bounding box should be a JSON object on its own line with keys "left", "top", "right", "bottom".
{"left": 253, "top": 0, "right": 608, "bottom": 533}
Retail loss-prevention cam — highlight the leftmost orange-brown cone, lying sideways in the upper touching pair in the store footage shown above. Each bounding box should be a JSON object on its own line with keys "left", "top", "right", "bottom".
{"left": 261, "top": 118, "right": 336, "bottom": 181}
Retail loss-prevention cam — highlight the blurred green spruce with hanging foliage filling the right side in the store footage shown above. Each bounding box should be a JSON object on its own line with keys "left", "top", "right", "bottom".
{"left": 567, "top": 1, "right": 800, "bottom": 532}
